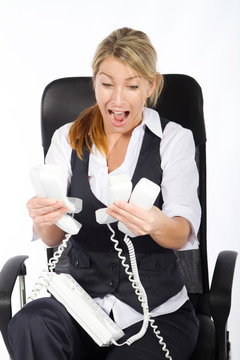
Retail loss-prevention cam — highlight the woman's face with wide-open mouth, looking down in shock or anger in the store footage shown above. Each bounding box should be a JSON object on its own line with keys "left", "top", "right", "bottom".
{"left": 94, "top": 56, "right": 154, "bottom": 135}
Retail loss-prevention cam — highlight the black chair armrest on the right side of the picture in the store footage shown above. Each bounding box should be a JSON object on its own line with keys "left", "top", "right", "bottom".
{"left": 209, "top": 251, "right": 238, "bottom": 360}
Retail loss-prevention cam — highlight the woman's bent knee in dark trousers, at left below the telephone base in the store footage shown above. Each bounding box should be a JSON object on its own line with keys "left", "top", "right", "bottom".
{"left": 8, "top": 298, "right": 80, "bottom": 360}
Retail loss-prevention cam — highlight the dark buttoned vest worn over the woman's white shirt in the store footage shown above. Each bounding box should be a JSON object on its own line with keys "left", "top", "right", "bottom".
{"left": 68, "top": 119, "right": 183, "bottom": 312}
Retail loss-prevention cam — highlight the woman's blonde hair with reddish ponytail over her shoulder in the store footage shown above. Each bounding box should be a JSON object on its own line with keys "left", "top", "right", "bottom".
{"left": 69, "top": 27, "right": 163, "bottom": 158}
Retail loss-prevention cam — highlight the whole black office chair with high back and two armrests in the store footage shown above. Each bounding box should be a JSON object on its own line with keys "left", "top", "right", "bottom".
{"left": 0, "top": 74, "right": 237, "bottom": 360}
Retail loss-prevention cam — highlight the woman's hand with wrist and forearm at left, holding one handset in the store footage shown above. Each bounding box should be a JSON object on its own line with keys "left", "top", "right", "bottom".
{"left": 27, "top": 196, "right": 69, "bottom": 246}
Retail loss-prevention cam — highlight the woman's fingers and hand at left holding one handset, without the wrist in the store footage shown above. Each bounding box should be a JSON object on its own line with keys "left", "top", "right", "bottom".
{"left": 27, "top": 196, "right": 69, "bottom": 227}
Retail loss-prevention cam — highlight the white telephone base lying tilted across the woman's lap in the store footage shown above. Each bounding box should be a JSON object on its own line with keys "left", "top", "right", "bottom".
{"left": 47, "top": 272, "right": 124, "bottom": 346}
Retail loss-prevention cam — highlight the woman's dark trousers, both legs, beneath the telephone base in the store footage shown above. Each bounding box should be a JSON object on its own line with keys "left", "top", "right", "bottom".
{"left": 9, "top": 297, "right": 198, "bottom": 360}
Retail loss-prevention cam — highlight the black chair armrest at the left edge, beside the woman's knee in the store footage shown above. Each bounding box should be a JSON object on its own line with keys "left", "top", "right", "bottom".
{"left": 0, "top": 255, "right": 28, "bottom": 355}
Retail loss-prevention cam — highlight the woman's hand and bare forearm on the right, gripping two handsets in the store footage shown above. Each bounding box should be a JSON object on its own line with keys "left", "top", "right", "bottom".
{"left": 107, "top": 201, "right": 191, "bottom": 250}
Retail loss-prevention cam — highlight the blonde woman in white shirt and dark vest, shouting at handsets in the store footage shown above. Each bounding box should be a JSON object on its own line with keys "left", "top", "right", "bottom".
{"left": 9, "top": 28, "right": 200, "bottom": 360}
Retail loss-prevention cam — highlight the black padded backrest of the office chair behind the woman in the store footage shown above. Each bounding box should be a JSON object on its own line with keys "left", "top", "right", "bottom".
{"left": 41, "top": 74, "right": 209, "bottom": 308}
